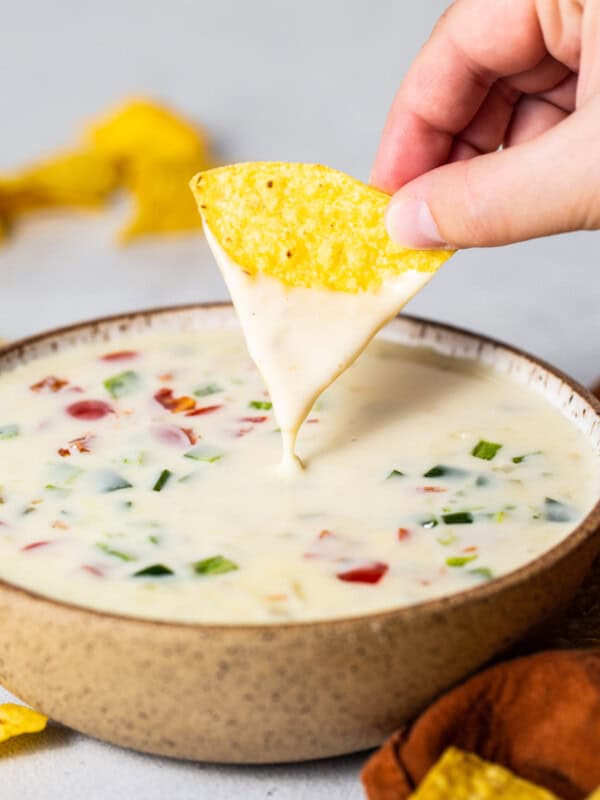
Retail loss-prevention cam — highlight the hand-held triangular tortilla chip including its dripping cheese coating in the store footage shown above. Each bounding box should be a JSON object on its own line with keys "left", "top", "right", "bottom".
{"left": 191, "top": 162, "right": 451, "bottom": 461}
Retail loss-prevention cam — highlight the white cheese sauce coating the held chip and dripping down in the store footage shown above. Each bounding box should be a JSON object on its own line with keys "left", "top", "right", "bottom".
{"left": 204, "top": 224, "right": 435, "bottom": 469}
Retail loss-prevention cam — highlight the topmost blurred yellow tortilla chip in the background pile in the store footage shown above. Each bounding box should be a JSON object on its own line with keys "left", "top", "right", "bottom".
{"left": 87, "top": 99, "right": 207, "bottom": 166}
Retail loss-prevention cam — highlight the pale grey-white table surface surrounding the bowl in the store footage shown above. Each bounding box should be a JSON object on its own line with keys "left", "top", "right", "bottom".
{"left": 0, "top": 0, "right": 600, "bottom": 800}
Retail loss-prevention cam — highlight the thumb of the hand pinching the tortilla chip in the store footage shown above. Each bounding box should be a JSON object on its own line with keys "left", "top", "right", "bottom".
{"left": 386, "top": 97, "right": 600, "bottom": 249}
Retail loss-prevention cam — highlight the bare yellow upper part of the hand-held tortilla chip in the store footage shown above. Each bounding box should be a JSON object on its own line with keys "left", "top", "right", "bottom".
{"left": 190, "top": 162, "right": 452, "bottom": 292}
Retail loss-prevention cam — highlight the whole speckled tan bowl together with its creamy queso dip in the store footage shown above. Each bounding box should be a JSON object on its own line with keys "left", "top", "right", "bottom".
{"left": 0, "top": 305, "right": 600, "bottom": 763}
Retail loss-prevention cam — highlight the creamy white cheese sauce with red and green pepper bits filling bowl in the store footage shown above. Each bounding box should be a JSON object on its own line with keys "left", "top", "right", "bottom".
{"left": 0, "top": 328, "right": 599, "bottom": 623}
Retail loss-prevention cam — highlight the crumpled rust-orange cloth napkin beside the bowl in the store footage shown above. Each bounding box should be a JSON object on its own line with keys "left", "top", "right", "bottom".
{"left": 362, "top": 650, "right": 600, "bottom": 800}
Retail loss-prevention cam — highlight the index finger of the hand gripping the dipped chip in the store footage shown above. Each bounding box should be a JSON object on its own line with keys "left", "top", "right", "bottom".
{"left": 371, "top": 0, "right": 547, "bottom": 194}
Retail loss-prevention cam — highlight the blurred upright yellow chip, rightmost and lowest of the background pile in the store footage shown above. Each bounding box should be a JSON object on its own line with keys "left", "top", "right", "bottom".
{"left": 119, "top": 159, "right": 209, "bottom": 242}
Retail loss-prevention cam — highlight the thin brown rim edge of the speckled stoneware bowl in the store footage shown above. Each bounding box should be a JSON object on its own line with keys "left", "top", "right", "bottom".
{"left": 0, "top": 300, "right": 600, "bottom": 633}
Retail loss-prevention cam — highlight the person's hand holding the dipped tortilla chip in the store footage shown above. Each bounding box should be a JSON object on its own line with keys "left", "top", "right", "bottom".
{"left": 371, "top": 0, "right": 600, "bottom": 248}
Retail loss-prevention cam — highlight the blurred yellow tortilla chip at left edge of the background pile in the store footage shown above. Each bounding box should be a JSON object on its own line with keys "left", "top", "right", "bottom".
{"left": 0, "top": 150, "right": 118, "bottom": 212}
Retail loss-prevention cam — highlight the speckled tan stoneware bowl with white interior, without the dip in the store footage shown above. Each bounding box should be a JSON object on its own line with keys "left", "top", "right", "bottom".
{"left": 0, "top": 306, "right": 600, "bottom": 763}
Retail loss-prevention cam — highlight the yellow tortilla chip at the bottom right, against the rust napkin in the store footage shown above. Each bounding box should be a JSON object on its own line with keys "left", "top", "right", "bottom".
{"left": 411, "top": 747, "right": 558, "bottom": 800}
